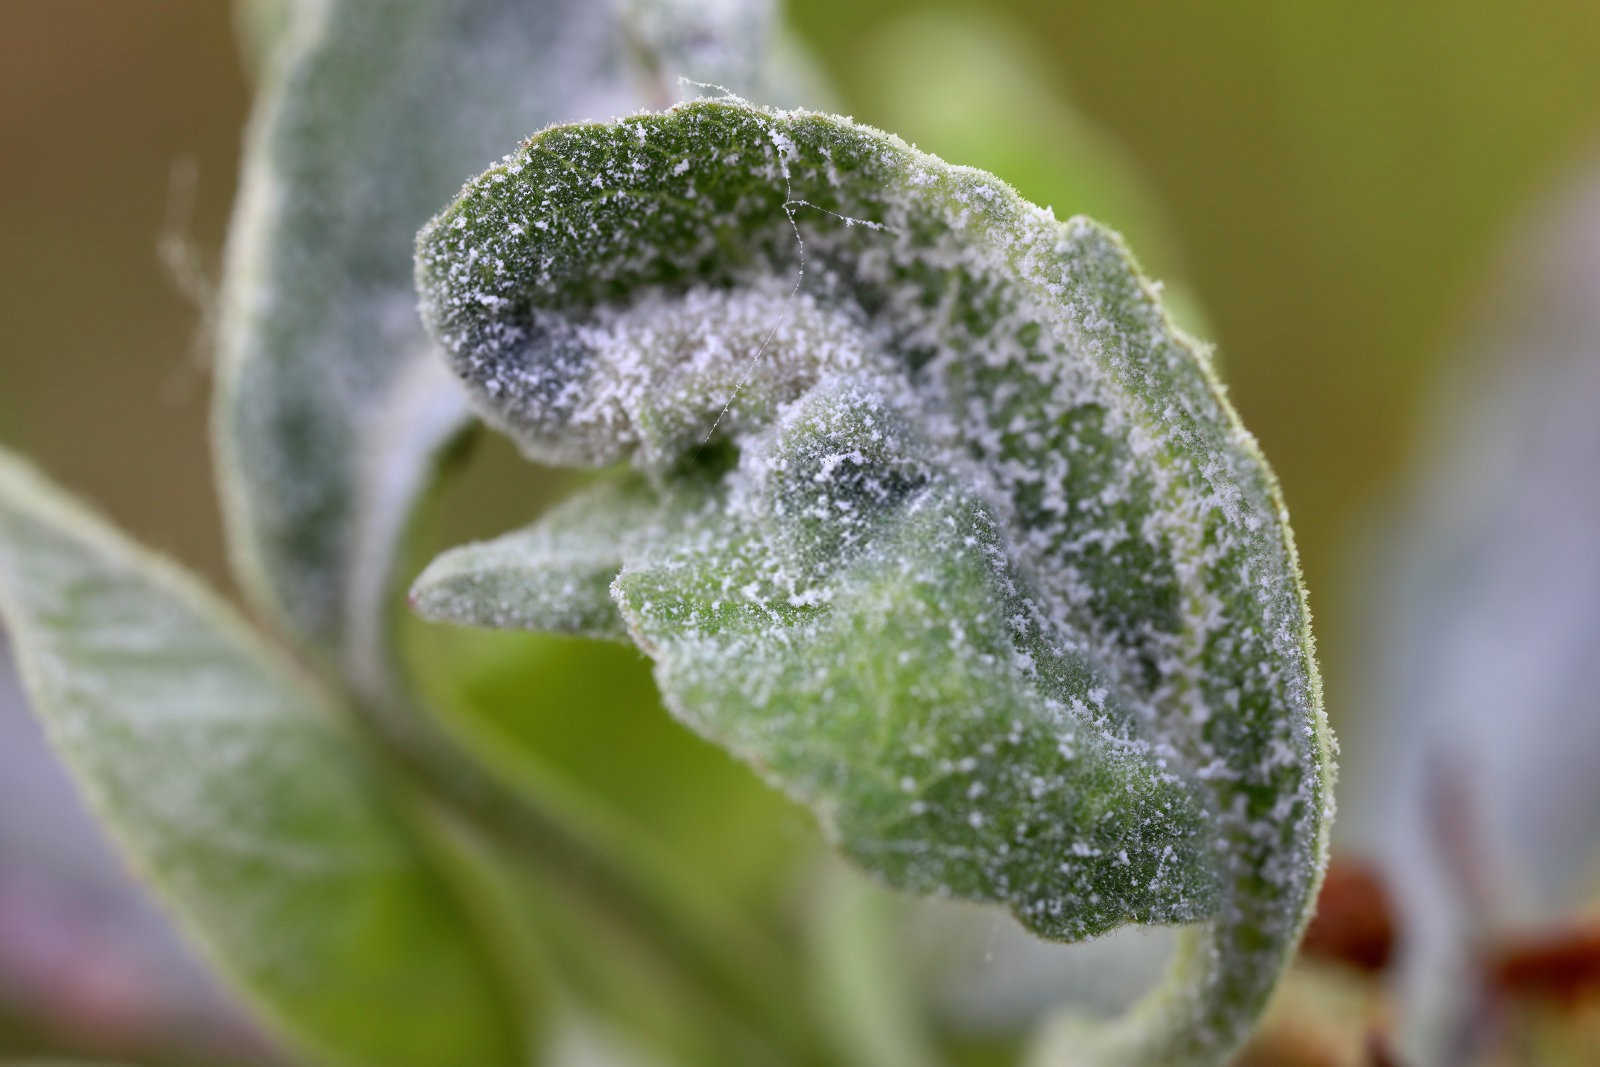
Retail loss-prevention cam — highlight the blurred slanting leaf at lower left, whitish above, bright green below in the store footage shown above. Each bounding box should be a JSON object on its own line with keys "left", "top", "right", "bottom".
{"left": 0, "top": 456, "right": 523, "bottom": 1067}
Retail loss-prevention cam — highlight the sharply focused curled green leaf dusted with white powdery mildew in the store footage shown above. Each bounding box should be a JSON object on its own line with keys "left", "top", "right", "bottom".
{"left": 418, "top": 101, "right": 1331, "bottom": 1062}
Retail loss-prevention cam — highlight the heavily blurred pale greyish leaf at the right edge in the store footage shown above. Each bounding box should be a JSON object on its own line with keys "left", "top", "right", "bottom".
{"left": 1344, "top": 158, "right": 1600, "bottom": 1064}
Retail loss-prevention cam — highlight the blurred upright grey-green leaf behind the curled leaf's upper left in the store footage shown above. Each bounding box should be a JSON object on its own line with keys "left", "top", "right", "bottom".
{"left": 214, "top": 0, "right": 800, "bottom": 696}
